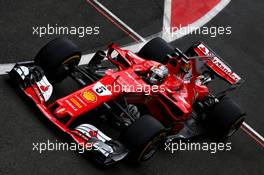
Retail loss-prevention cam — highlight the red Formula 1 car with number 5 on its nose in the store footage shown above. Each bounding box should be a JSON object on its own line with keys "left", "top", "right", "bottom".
{"left": 9, "top": 38, "right": 245, "bottom": 165}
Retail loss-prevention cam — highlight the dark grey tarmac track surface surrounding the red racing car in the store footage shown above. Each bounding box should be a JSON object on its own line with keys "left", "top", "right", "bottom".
{"left": 0, "top": 0, "right": 264, "bottom": 175}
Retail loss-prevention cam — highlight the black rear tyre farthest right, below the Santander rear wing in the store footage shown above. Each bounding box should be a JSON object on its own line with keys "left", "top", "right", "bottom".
{"left": 205, "top": 96, "right": 245, "bottom": 141}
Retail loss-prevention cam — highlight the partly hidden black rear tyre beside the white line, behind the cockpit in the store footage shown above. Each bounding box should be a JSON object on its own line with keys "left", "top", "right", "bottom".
{"left": 138, "top": 38, "right": 174, "bottom": 64}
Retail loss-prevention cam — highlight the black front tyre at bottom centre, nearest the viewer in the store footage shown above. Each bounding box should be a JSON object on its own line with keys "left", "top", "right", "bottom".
{"left": 120, "top": 115, "right": 166, "bottom": 163}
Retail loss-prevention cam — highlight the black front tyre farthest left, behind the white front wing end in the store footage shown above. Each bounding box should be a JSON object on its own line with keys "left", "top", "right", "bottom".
{"left": 34, "top": 38, "right": 81, "bottom": 83}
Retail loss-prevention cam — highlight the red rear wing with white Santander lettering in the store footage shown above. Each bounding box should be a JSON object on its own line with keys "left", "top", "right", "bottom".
{"left": 193, "top": 42, "right": 244, "bottom": 85}
